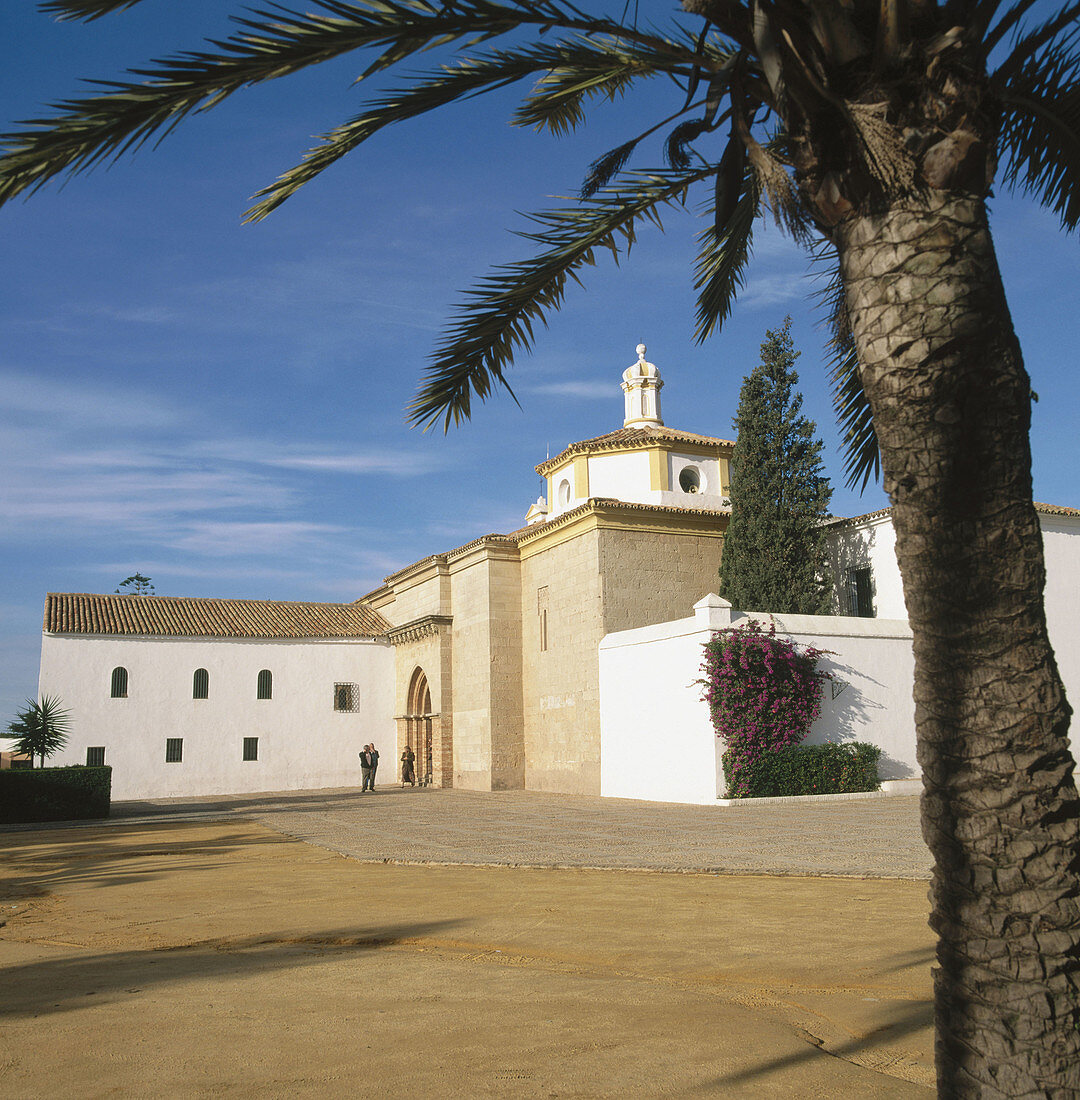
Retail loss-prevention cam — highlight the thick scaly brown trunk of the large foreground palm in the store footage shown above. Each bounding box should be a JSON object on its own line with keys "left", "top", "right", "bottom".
{"left": 836, "top": 193, "right": 1080, "bottom": 1100}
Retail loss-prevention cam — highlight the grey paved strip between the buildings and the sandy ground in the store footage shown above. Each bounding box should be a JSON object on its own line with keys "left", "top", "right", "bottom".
{"left": 95, "top": 787, "right": 930, "bottom": 879}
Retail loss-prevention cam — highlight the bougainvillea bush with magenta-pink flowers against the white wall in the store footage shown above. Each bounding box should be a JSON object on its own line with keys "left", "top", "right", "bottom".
{"left": 698, "top": 619, "right": 830, "bottom": 798}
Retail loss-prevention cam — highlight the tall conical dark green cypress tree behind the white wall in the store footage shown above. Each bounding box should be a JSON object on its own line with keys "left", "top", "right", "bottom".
{"left": 720, "top": 317, "right": 833, "bottom": 615}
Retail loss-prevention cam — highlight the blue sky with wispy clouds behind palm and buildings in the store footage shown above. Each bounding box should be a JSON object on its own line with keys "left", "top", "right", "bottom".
{"left": 0, "top": 0, "right": 1080, "bottom": 723}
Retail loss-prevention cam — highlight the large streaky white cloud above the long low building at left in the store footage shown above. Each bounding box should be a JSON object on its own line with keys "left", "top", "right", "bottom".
{"left": 0, "top": 373, "right": 445, "bottom": 560}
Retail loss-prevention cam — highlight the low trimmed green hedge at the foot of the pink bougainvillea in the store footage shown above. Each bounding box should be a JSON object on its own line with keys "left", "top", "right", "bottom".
{"left": 724, "top": 741, "right": 881, "bottom": 799}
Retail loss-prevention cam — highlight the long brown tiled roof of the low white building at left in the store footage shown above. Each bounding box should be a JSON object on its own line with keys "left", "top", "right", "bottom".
{"left": 44, "top": 592, "right": 390, "bottom": 638}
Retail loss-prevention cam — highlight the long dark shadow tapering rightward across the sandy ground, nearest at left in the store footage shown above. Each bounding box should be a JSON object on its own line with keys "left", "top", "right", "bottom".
{"left": 0, "top": 920, "right": 463, "bottom": 1019}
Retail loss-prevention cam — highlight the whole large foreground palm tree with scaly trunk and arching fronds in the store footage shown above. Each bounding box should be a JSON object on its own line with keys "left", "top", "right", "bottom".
{"left": 0, "top": 0, "right": 1080, "bottom": 1097}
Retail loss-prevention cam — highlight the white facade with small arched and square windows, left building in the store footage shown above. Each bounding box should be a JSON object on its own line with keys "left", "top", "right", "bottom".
{"left": 38, "top": 635, "right": 396, "bottom": 801}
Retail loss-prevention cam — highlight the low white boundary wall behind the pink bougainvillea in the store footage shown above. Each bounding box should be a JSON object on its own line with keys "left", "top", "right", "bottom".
{"left": 599, "top": 595, "right": 919, "bottom": 804}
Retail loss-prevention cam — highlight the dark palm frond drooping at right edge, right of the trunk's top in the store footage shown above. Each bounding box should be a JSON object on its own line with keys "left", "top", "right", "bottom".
{"left": 999, "top": 35, "right": 1080, "bottom": 229}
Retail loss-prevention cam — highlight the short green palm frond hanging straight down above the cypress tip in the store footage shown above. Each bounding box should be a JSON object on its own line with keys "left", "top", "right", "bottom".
{"left": 694, "top": 155, "right": 761, "bottom": 343}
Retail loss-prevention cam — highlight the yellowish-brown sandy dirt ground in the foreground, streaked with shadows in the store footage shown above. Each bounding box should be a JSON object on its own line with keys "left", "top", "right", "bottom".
{"left": 0, "top": 821, "right": 933, "bottom": 1100}
